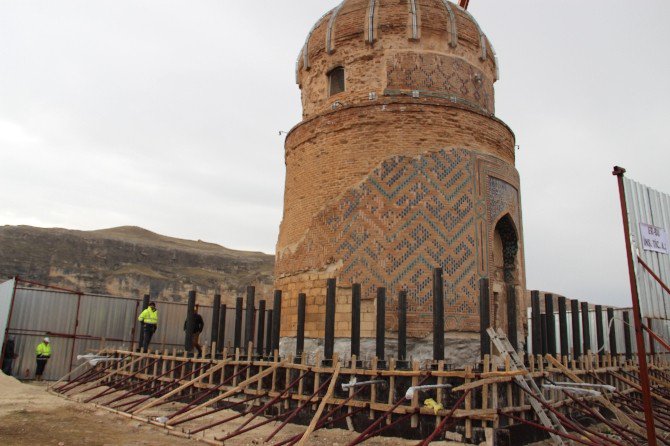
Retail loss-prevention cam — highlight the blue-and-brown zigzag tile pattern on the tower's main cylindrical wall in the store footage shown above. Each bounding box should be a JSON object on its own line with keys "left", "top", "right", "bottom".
{"left": 276, "top": 149, "right": 520, "bottom": 337}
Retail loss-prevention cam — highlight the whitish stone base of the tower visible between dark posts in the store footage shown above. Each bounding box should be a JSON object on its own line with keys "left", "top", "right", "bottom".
{"left": 279, "top": 333, "right": 481, "bottom": 368}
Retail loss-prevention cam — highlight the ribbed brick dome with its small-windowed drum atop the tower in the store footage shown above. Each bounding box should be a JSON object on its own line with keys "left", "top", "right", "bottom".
{"left": 296, "top": 0, "right": 498, "bottom": 118}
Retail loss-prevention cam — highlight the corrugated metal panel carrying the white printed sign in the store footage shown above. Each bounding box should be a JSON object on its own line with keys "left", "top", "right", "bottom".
{"left": 624, "top": 178, "right": 670, "bottom": 320}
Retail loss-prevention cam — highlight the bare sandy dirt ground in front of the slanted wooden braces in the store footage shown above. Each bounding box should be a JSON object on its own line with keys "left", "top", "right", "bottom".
{"left": 0, "top": 373, "right": 468, "bottom": 446}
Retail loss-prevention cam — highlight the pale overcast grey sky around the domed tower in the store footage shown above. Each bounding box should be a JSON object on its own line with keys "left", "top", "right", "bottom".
{"left": 0, "top": 0, "right": 670, "bottom": 306}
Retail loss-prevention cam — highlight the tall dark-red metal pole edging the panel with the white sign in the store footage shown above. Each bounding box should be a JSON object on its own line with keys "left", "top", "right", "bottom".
{"left": 612, "top": 166, "right": 657, "bottom": 446}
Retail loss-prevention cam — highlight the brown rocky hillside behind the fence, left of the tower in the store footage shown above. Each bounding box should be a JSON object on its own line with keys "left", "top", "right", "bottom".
{"left": 0, "top": 226, "right": 274, "bottom": 302}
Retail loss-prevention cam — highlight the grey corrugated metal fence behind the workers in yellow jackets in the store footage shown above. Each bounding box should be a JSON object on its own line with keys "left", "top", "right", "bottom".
{"left": 0, "top": 280, "right": 267, "bottom": 379}
